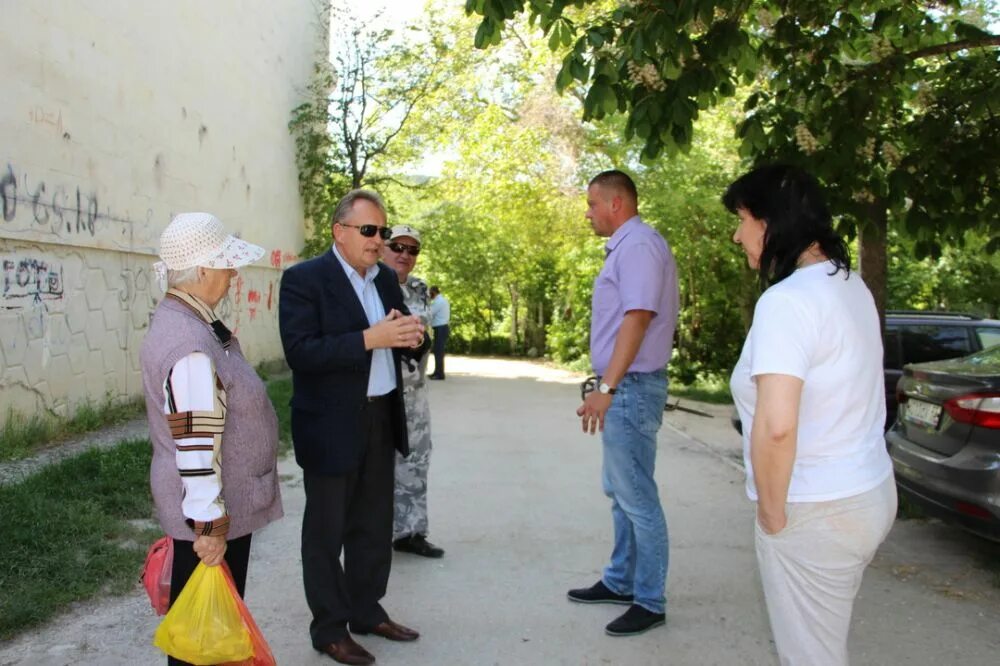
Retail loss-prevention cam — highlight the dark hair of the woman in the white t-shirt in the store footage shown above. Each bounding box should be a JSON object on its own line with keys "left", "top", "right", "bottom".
{"left": 722, "top": 164, "right": 851, "bottom": 288}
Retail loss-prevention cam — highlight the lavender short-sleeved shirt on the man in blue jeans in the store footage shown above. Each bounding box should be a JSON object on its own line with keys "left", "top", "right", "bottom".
{"left": 590, "top": 215, "right": 680, "bottom": 375}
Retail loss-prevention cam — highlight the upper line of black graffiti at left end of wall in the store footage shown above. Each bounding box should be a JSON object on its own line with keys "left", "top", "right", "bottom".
{"left": 0, "top": 164, "right": 153, "bottom": 249}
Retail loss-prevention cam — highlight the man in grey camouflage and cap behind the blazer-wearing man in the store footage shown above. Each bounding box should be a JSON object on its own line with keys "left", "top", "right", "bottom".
{"left": 382, "top": 224, "right": 444, "bottom": 557}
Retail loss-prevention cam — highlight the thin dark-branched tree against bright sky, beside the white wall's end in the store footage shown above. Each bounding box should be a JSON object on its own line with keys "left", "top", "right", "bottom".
{"left": 289, "top": 9, "right": 461, "bottom": 257}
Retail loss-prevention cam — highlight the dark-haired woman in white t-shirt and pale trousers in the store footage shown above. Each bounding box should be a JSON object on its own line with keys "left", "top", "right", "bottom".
{"left": 722, "top": 165, "right": 896, "bottom": 666}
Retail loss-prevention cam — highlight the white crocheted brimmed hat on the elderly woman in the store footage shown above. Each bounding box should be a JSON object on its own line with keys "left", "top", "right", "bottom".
{"left": 153, "top": 213, "right": 264, "bottom": 286}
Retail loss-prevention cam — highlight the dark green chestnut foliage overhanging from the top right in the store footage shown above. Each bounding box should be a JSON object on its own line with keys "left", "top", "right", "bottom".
{"left": 466, "top": 0, "right": 1000, "bottom": 316}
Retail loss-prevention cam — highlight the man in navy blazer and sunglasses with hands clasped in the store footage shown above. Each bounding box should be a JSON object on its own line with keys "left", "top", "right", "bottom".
{"left": 278, "top": 190, "right": 429, "bottom": 664}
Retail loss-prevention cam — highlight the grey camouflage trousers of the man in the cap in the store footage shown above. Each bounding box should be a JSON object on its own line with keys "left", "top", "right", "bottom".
{"left": 392, "top": 380, "right": 431, "bottom": 540}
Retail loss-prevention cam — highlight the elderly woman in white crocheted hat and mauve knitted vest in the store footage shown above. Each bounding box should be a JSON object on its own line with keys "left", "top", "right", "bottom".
{"left": 139, "top": 213, "right": 282, "bottom": 664}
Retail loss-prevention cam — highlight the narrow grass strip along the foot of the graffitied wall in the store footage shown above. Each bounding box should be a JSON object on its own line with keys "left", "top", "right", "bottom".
{"left": 0, "top": 396, "right": 145, "bottom": 461}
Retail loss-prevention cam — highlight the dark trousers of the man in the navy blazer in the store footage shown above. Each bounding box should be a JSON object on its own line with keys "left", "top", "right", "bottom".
{"left": 302, "top": 398, "right": 396, "bottom": 647}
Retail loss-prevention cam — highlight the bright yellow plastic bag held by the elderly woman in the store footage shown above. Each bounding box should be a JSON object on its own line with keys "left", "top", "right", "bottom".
{"left": 153, "top": 562, "right": 253, "bottom": 666}
